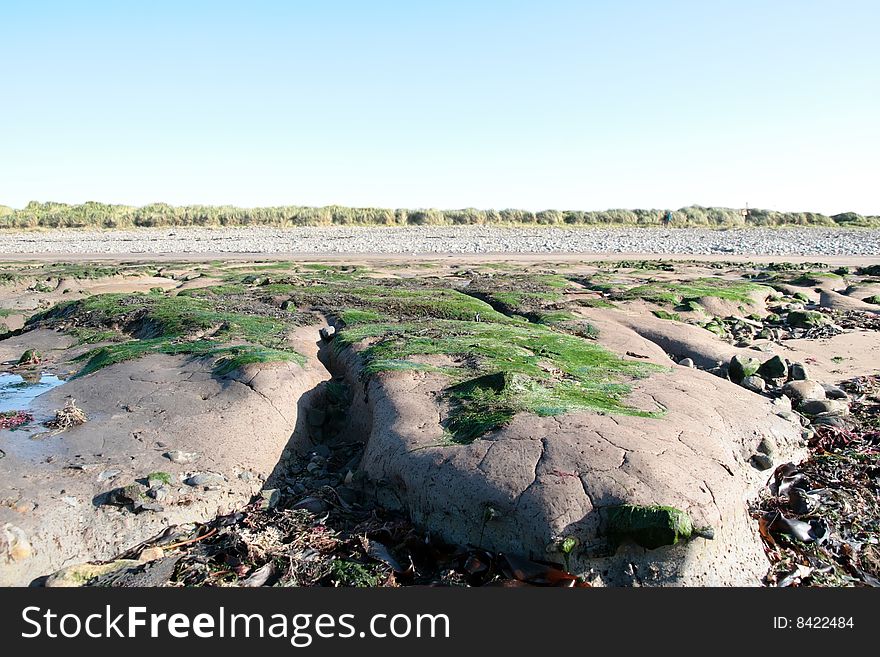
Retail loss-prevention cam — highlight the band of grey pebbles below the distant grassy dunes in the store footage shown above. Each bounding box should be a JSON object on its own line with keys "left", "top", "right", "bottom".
{"left": 0, "top": 226, "right": 880, "bottom": 256}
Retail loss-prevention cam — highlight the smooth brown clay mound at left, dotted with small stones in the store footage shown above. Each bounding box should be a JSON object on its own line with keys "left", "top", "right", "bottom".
{"left": 0, "top": 332, "right": 323, "bottom": 586}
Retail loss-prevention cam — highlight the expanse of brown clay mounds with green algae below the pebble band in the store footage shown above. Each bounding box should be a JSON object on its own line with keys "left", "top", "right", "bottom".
{"left": 0, "top": 255, "right": 880, "bottom": 585}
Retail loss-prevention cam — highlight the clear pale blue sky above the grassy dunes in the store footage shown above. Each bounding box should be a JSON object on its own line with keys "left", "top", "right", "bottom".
{"left": 0, "top": 0, "right": 880, "bottom": 214}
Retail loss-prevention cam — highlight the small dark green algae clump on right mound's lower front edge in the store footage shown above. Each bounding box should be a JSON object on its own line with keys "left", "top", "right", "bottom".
{"left": 607, "top": 504, "right": 705, "bottom": 550}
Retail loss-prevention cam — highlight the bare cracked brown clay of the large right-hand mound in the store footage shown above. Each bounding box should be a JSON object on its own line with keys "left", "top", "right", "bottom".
{"left": 330, "top": 336, "right": 801, "bottom": 585}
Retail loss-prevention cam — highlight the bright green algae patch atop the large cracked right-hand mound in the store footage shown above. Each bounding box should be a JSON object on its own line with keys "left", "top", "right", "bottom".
{"left": 334, "top": 320, "right": 668, "bottom": 443}
